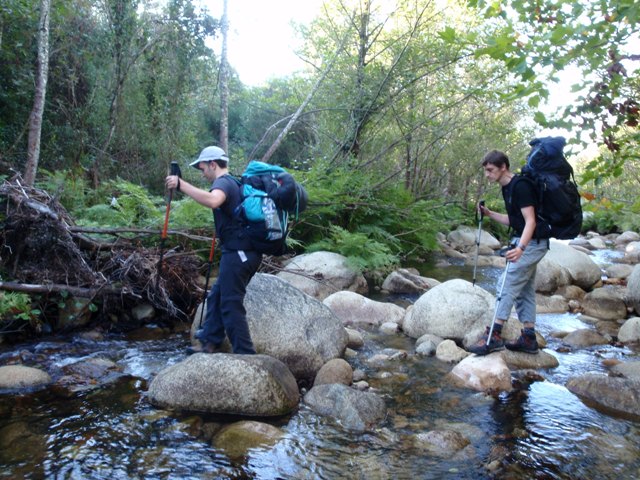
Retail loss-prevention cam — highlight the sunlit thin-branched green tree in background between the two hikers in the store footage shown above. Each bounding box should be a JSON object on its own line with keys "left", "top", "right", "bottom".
{"left": 294, "top": 0, "right": 525, "bottom": 201}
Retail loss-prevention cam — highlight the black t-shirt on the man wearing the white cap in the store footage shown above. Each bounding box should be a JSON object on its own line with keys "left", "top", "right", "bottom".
{"left": 209, "top": 175, "right": 252, "bottom": 251}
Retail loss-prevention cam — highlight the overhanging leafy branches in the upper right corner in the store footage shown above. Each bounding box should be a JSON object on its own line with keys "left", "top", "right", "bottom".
{"left": 458, "top": 0, "right": 640, "bottom": 175}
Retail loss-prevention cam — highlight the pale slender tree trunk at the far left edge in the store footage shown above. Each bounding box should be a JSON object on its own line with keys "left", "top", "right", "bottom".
{"left": 24, "top": 0, "right": 51, "bottom": 186}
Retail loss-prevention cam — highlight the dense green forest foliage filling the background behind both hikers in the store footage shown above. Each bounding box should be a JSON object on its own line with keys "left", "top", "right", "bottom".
{"left": 0, "top": 0, "right": 638, "bottom": 290}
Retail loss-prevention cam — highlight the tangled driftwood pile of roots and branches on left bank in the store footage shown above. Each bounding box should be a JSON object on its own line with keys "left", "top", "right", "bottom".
{"left": 0, "top": 178, "right": 203, "bottom": 334}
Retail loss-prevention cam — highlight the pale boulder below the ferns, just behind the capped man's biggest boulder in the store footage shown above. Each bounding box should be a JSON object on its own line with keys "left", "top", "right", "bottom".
{"left": 277, "top": 252, "right": 369, "bottom": 300}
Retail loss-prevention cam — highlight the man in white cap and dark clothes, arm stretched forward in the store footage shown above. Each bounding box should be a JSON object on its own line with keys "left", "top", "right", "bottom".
{"left": 165, "top": 146, "right": 262, "bottom": 354}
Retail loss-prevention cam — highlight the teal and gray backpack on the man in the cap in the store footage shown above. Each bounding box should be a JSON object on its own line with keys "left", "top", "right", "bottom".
{"left": 234, "top": 160, "right": 308, "bottom": 255}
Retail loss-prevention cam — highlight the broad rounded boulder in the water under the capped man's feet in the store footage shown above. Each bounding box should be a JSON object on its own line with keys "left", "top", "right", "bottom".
{"left": 148, "top": 353, "right": 299, "bottom": 417}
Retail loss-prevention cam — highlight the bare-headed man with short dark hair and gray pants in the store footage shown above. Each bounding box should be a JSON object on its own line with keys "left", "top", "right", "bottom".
{"left": 468, "top": 150, "right": 549, "bottom": 355}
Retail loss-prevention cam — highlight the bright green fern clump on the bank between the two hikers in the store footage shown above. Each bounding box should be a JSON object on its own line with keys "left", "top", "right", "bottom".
{"left": 293, "top": 162, "right": 464, "bottom": 271}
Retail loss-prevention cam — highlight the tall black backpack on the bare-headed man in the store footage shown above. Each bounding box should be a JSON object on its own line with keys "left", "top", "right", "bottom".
{"left": 518, "top": 137, "right": 582, "bottom": 240}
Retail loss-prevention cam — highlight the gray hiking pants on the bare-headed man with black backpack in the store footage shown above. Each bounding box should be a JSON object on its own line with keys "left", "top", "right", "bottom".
{"left": 496, "top": 238, "right": 549, "bottom": 323}
